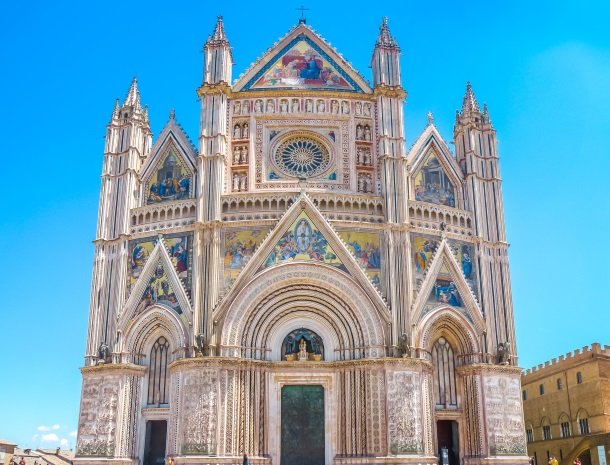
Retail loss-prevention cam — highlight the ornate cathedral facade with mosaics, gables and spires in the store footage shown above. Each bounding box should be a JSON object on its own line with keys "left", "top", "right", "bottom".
{"left": 74, "top": 18, "right": 527, "bottom": 465}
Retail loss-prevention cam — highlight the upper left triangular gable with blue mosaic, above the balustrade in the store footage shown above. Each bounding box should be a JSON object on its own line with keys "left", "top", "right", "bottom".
{"left": 140, "top": 118, "right": 197, "bottom": 204}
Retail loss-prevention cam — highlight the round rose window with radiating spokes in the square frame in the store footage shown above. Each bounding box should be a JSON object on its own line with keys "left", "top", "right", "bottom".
{"left": 274, "top": 136, "right": 330, "bottom": 178}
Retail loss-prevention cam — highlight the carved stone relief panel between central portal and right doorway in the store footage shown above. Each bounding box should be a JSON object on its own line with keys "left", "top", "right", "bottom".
{"left": 387, "top": 371, "right": 422, "bottom": 455}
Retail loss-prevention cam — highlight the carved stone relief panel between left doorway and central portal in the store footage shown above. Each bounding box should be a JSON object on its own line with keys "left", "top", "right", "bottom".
{"left": 181, "top": 370, "right": 218, "bottom": 455}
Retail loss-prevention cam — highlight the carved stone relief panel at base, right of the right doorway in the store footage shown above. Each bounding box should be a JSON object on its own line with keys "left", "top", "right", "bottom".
{"left": 483, "top": 375, "right": 527, "bottom": 455}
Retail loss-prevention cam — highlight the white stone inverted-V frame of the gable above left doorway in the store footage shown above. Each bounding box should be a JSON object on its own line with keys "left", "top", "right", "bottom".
{"left": 118, "top": 237, "right": 193, "bottom": 329}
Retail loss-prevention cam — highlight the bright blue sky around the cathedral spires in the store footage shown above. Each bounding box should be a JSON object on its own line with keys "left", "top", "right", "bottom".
{"left": 0, "top": 0, "right": 610, "bottom": 447}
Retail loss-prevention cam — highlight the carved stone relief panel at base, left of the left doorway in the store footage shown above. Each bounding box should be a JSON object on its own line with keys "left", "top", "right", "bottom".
{"left": 76, "top": 376, "right": 119, "bottom": 457}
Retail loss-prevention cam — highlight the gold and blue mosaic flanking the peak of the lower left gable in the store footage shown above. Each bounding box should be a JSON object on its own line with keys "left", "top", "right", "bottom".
{"left": 127, "top": 233, "right": 193, "bottom": 296}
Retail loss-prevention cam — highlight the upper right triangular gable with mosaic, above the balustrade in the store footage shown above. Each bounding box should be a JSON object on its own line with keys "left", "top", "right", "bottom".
{"left": 407, "top": 124, "right": 463, "bottom": 207}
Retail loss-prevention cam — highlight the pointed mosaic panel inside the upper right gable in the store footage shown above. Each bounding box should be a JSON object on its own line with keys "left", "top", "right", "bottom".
{"left": 415, "top": 152, "right": 455, "bottom": 207}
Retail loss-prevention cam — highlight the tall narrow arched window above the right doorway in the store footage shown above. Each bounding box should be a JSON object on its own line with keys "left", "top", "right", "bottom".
{"left": 432, "top": 337, "right": 457, "bottom": 408}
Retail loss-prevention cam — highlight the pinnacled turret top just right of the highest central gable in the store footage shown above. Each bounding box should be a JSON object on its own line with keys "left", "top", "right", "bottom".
{"left": 371, "top": 17, "right": 401, "bottom": 87}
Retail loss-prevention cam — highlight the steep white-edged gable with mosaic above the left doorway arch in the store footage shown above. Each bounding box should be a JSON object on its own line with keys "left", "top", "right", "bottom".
{"left": 119, "top": 238, "right": 192, "bottom": 327}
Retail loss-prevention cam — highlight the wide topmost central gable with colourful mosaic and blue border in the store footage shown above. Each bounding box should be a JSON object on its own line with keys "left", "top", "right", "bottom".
{"left": 233, "top": 24, "right": 372, "bottom": 93}
